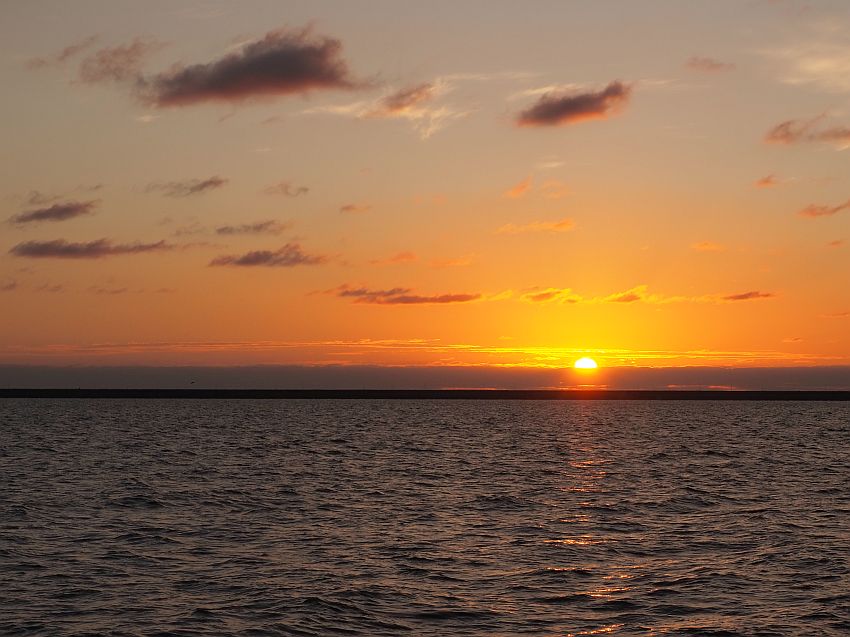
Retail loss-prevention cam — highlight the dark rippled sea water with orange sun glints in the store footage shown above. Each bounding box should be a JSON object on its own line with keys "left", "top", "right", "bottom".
{"left": 0, "top": 400, "right": 850, "bottom": 637}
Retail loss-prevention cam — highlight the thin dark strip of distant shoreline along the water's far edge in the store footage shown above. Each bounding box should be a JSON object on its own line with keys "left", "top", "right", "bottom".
{"left": 0, "top": 388, "right": 850, "bottom": 401}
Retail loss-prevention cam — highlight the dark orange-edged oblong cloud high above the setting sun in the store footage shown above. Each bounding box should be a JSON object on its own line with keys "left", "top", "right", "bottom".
{"left": 516, "top": 81, "right": 632, "bottom": 126}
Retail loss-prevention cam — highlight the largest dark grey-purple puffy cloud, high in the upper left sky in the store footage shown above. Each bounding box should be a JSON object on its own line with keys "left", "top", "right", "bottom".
{"left": 139, "top": 28, "right": 357, "bottom": 107}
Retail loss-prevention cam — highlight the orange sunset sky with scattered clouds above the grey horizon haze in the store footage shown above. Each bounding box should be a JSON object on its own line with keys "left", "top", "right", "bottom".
{"left": 0, "top": 0, "right": 850, "bottom": 385}
